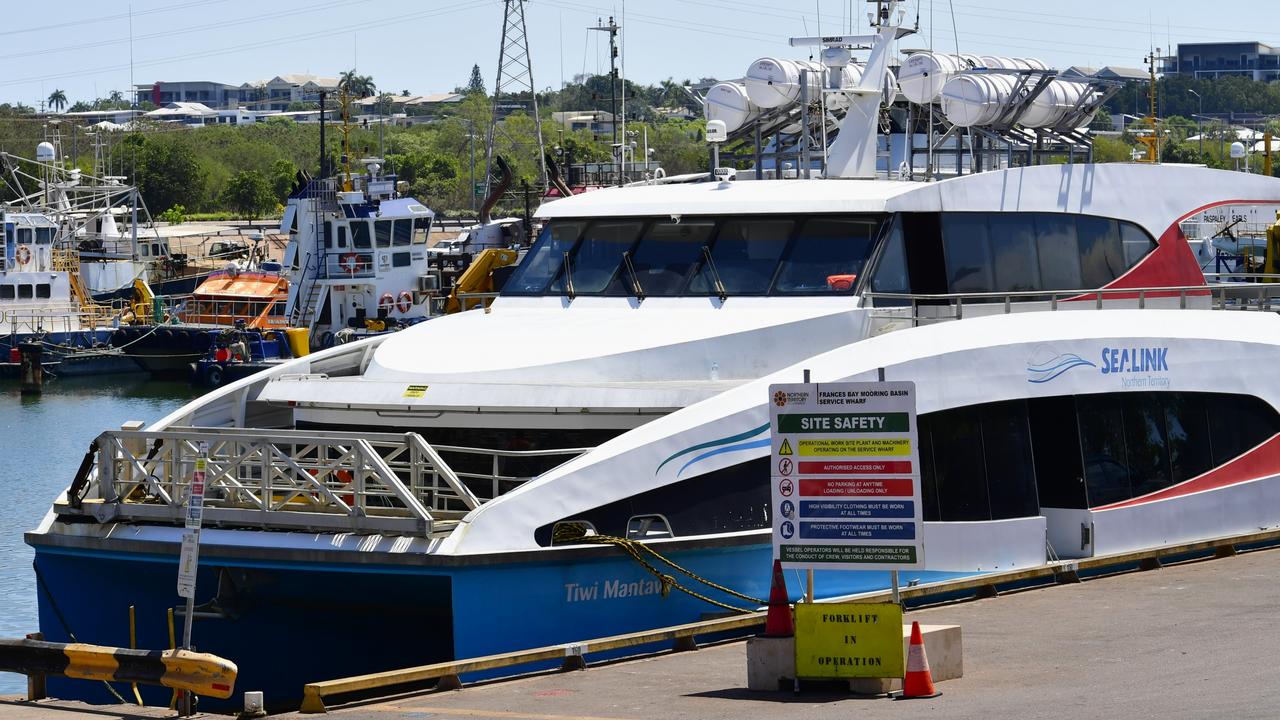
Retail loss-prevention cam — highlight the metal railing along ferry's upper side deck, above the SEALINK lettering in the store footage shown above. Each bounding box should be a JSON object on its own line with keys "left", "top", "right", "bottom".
{"left": 863, "top": 278, "right": 1280, "bottom": 327}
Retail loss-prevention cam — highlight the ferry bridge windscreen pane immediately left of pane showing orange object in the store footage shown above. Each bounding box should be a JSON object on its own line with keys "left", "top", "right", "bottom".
{"left": 689, "top": 218, "right": 795, "bottom": 295}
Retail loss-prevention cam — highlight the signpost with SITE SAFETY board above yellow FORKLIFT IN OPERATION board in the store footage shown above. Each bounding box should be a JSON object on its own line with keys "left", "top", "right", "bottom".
{"left": 769, "top": 375, "right": 924, "bottom": 678}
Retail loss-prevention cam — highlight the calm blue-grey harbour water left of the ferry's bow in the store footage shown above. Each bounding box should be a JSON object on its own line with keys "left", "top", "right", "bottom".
{"left": 0, "top": 375, "right": 197, "bottom": 694}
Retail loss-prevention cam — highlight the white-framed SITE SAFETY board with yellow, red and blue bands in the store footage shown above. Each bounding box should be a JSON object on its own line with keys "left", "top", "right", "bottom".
{"left": 769, "top": 382, "right": 924, "bottom": 570}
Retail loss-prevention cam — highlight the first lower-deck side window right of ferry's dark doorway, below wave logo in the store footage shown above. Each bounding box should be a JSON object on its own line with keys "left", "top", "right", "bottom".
{"left": 1075, "top": 395, "right": 1133, "bottom": 507}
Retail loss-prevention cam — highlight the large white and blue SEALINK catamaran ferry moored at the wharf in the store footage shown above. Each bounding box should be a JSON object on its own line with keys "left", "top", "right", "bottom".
{"left": 26, "top": 1, "right": 1280, "bottom": 703}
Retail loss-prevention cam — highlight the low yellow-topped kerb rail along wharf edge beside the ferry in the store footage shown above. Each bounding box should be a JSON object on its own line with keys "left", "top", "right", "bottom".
{"left": 300, "top": 520, "right": 1280, "bottom": 712}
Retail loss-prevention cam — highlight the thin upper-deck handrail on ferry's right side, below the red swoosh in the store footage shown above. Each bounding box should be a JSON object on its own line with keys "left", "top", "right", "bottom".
{"left": 863, "top": 278, "right": 1280, "bottom": 323}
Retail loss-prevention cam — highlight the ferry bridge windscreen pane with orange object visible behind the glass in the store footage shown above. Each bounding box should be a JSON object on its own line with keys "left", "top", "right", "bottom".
{"left": 773, "top": 218, "right": 884, "bottom": 295}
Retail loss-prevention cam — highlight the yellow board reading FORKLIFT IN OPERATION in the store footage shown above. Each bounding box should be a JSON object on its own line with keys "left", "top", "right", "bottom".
{"left": 795, "top": 602, "right": 905, "bottom": 678}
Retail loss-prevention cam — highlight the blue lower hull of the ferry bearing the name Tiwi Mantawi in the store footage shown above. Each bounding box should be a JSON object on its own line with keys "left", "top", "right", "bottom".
{"left": 27, "top": 544, "right": 960, "bottom": 710}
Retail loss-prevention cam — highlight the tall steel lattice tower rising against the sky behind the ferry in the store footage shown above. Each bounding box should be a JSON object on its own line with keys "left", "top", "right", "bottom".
{"left": 485, "top": 0, "right": 547, "bottom": 192}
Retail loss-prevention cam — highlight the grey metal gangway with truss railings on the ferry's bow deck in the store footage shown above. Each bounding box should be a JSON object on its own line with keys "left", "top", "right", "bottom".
{"left": 56, "top": 427, "right": 586, "bottom": 537}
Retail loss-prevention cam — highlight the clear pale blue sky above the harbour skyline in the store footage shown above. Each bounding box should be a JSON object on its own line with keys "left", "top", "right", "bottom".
{"left": 0, "top": 0, "right": 1280, "bottom": 106}
